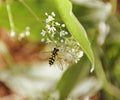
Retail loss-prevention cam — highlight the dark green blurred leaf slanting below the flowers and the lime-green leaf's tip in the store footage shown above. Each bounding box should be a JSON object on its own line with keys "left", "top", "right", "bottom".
{"left": 57, "top": 57, "right": 89, "bottom": 100}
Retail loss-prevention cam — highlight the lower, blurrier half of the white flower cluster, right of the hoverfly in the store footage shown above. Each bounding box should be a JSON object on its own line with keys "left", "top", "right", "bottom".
{"left": 59, "top": 37, "right": 83, "bottom": 64}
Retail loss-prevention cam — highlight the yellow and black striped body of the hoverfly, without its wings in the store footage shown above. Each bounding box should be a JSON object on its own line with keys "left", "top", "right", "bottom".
{"left": 49, "top": 48, "right": 59, "bottom": 66}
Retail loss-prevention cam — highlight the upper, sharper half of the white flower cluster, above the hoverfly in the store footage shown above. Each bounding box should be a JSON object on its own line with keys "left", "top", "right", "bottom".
{"left": 40, "top": 12, "right": 68, "bottom": 43}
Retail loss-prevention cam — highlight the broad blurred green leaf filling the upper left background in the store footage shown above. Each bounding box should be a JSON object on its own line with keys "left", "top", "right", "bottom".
{"left": 0, "top": 0, "right": 57, "bottom": 41}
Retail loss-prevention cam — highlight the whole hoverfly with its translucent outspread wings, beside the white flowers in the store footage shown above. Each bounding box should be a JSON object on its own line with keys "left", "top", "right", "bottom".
{"left": 40, "top": 45, "right": 65, "bottom": 69}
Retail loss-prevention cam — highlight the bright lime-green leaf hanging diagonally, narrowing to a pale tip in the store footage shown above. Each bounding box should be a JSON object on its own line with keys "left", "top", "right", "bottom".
{"left": 55, "top": 0, "right": 94, "bottom": 71}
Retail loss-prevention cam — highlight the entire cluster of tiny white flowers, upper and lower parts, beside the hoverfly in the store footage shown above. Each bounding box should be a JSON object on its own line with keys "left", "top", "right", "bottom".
{"left": 40, "top": 12, "right": 83, "bottom": 65}
